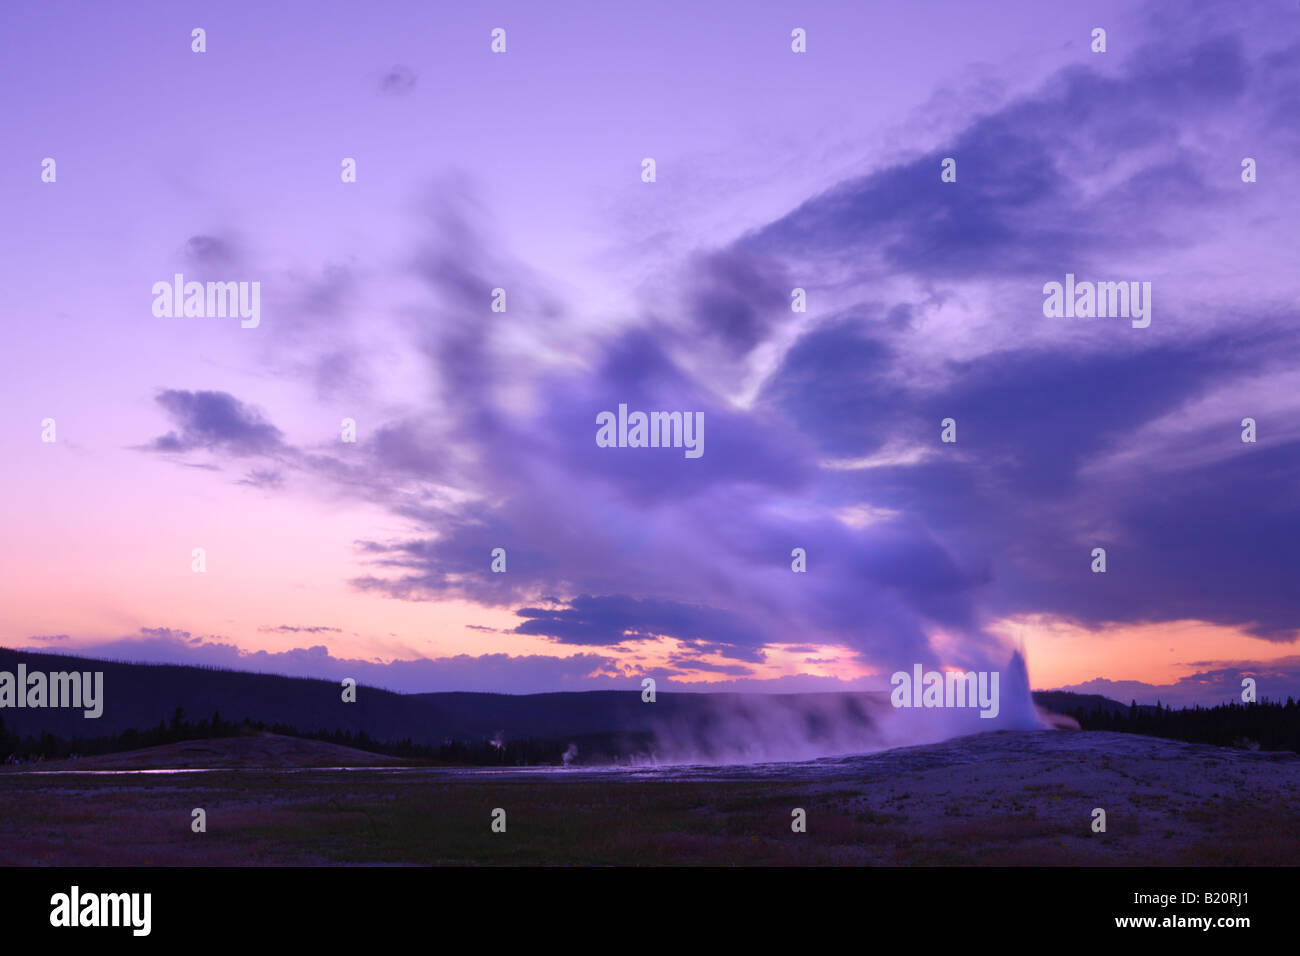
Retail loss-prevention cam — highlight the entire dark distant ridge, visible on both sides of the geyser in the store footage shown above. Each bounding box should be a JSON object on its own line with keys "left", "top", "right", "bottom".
{"left": 0, "top": 648, "right": 1300, "bottom": 765}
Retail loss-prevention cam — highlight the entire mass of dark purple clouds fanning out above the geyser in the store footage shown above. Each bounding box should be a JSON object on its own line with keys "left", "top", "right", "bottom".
{"left": 155, "top": 11, "right": 1300, "bottom": 672}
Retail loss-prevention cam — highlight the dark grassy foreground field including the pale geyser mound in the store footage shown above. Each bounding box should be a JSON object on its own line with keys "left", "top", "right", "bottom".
{"left": 0, "top": 731, "right": 1300, "bottom": 866}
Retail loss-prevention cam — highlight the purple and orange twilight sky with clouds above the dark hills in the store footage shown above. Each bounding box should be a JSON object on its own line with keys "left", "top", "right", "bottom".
{"left": 0, "top": 0, "right": 1300, "bottom": 704}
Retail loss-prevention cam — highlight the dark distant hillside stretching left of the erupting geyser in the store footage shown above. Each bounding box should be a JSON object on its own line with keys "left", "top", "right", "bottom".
{"left": 0, "top": 648, "right": 888, "bottom": 757}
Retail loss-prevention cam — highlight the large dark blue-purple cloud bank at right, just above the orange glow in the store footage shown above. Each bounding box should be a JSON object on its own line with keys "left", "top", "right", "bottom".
{"left": 766, "top": 310, "right": 1300, "bottom": 640}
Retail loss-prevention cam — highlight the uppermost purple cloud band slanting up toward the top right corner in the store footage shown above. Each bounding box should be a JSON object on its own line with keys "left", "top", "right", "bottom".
{"left": 740, "top": 36, "right": 1245, "bottom": 280}
